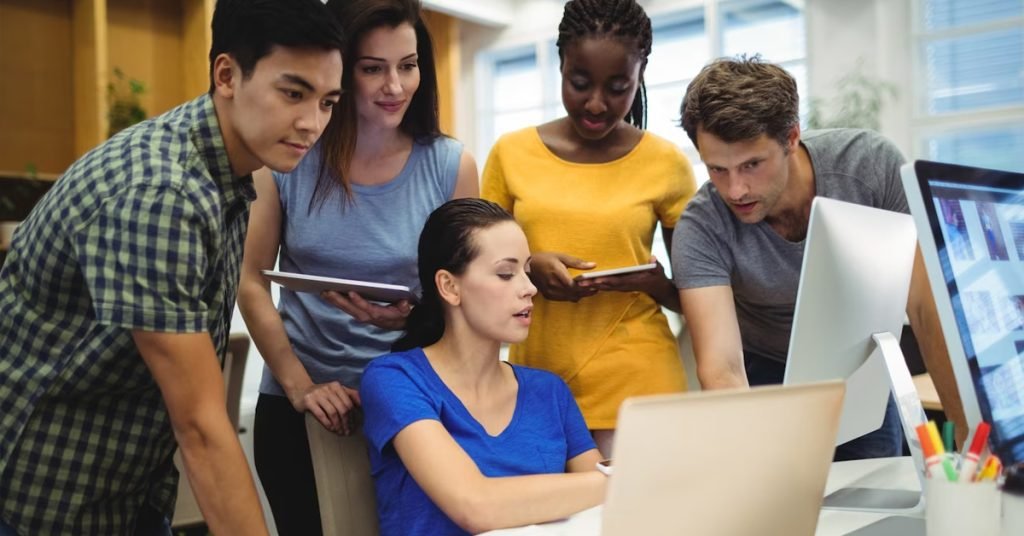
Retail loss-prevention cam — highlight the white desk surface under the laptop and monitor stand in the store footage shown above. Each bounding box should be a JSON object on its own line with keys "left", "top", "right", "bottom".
{"left": 485, "top": 457, "right": 924, "bottom": 536}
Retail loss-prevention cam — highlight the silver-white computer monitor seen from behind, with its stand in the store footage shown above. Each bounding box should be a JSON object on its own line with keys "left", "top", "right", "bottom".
{"left": 783, "top": 197, "right": 926, "bottom": 510}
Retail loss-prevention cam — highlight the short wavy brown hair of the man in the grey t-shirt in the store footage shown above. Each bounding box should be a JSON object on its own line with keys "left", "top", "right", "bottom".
{"left": 680, "top": 55, "right": 800, "bottom": 147}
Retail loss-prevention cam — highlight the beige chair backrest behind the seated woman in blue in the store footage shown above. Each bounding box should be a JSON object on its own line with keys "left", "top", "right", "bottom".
{"left": 306, "top": 413, "right": 378, "bottom": 536}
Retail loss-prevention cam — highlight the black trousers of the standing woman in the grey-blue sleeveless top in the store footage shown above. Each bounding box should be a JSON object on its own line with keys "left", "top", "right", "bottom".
{"left": 253, "top": 394, "right": 322, "bottom": 536}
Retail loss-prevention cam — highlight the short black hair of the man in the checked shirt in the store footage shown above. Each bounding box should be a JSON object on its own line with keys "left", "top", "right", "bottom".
{"left": 210, "top": 0, "right": 344, "bottom": 93}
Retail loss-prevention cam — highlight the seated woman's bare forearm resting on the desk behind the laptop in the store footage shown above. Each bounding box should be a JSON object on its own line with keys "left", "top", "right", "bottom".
{"left": 453, "top": 470, "right": 607, "bottom": 533}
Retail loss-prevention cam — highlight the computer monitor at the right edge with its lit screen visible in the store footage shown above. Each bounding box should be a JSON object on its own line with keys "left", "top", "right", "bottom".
{"left": 902, "top": 161, "right": 1024, "bottom": 464}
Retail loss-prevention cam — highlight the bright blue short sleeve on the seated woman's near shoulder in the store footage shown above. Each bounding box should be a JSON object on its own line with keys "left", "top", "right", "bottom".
{"left": 359, "top": 358, "right": 439, "bottom": 453}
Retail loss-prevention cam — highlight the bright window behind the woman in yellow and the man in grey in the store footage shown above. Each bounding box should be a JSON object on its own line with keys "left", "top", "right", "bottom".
{"left": 476, "top": 0, "right": 807, "bottom": 182}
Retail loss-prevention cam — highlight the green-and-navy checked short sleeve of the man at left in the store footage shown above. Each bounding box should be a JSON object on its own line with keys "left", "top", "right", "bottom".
{"left": 71, "top": 187, "right": 209, "bottom": 333}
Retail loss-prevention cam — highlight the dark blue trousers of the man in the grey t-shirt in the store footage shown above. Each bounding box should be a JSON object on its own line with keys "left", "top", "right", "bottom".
{"left": 745, "top": 357, "right": 903, "bottom": 461}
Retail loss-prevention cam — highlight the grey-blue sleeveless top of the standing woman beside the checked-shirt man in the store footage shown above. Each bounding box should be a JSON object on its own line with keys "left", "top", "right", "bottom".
{"left": 259, "top": 136, "right": 463, "bottom": 396}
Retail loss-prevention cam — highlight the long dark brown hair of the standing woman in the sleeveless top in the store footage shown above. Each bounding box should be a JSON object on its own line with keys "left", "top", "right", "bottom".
{"left": 309, "top": 0, "right": 441, "bottom": 210}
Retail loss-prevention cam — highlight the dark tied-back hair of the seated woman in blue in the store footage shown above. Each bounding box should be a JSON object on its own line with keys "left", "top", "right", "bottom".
{"left": 391, "top": 198, "right": 515, "bottom": 352}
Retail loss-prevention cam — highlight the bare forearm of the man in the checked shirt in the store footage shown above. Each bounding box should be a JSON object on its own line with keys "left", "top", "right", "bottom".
{"left": 174, "top": 414, "right": 267, "bottom": 535}
